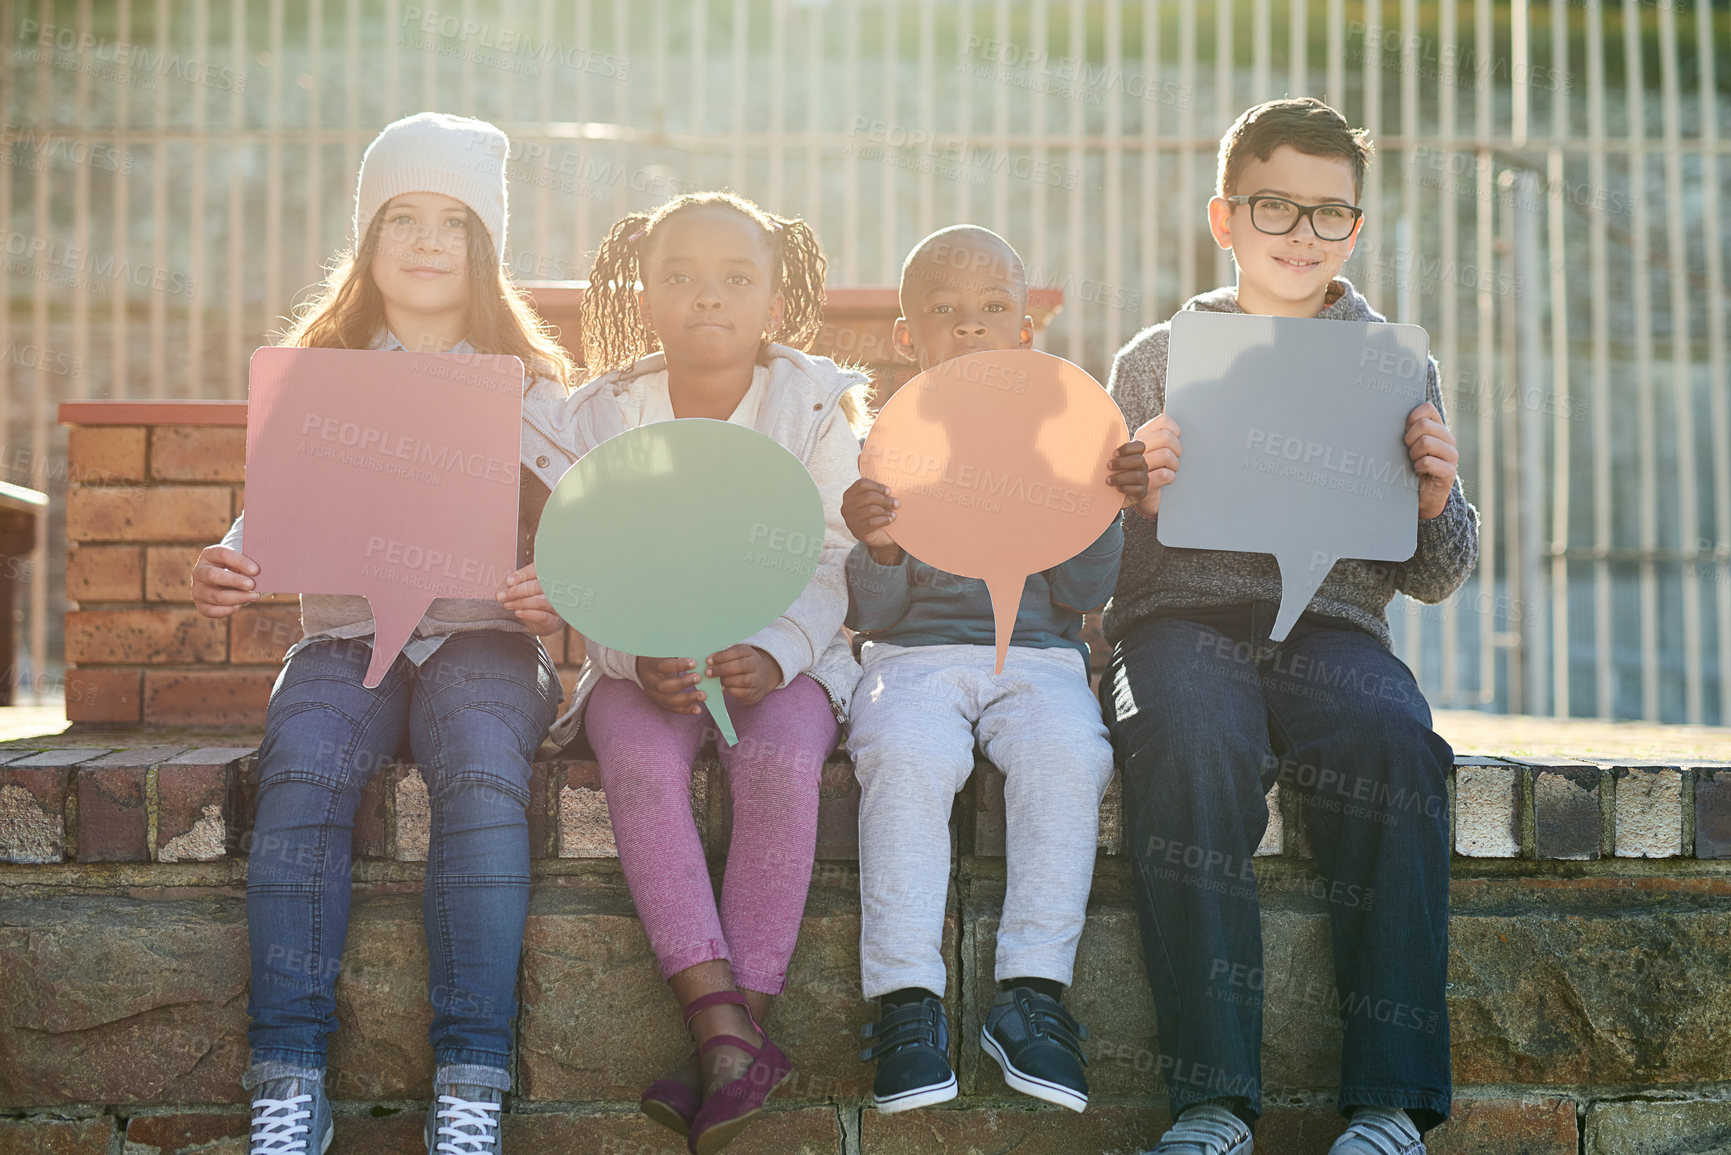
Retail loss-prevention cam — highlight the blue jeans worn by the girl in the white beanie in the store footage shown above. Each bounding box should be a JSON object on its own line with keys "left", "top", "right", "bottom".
{"left": 246, "top": 630, "right": 559, "bottom": 1070}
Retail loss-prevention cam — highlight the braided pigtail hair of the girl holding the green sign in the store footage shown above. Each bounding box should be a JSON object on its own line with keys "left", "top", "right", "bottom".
{"left": 582, "top": 192, "right": 829, "bottom": 374}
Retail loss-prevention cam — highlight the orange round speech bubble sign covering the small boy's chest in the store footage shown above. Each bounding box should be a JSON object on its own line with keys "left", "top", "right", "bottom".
{"left": 860, "top": 350, "right": 1130, "bottom": 674}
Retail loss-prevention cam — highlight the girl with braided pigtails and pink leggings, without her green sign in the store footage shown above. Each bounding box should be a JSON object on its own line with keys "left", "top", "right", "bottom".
{"left": 508, "top": 192, "right": 867, "bottom": 1155}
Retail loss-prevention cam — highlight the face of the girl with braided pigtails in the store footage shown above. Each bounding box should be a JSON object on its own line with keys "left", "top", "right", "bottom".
{"left": 637, "top": 208, "right": 782, "bottom": 367}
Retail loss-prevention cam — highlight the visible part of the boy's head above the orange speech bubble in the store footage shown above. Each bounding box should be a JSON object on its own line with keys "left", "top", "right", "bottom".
{"left": 895, "top": 239, "right": 1033, "bottom": 369}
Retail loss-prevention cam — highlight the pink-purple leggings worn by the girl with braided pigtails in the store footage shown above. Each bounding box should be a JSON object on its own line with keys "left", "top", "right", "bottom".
{"left": 585, "top": 674, "right": 836, "bottom": 994}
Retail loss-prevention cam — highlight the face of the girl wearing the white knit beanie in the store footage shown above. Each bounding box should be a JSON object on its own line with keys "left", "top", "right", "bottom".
{"left": 372, "top": 192, "right": 469, "bottom": 334}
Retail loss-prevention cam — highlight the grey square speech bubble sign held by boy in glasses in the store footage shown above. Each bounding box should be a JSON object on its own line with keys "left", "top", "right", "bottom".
{"left": 1158, "top": 310, "right": 1430, "bottom": 641}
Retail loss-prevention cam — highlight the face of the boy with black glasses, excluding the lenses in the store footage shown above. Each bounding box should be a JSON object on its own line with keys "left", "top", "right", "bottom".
{"left": 1208, "top": 144, "right": 1362, "bottom": 315}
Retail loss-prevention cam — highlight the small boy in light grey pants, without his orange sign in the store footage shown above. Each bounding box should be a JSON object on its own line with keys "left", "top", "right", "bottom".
{"left": 841, "top": 225, "right": 1148, "bottom": 1112}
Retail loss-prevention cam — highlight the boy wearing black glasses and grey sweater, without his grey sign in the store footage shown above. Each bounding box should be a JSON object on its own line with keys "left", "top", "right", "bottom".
{"left": 1101, "top": 99, "right": 1478, "bottom": 1155}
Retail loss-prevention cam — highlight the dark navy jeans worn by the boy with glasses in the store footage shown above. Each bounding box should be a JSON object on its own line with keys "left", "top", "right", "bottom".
{"left": 1103, "top": 603, "right": 1454, "bottom": 1129}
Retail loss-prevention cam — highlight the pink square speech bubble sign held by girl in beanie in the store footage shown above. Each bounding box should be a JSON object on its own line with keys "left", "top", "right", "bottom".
{"left": 246, "top": 346, "right": 523, "bottom": 687}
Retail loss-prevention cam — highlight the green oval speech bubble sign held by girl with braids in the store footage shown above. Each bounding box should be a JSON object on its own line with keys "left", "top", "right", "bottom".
{"left": 535, "top": 417, "right": 826, "bottom": 746}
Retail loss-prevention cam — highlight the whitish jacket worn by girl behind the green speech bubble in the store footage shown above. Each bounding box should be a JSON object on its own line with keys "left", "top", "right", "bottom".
{"left": 523, "top": 345, "right": 869, "bottom": 746}
